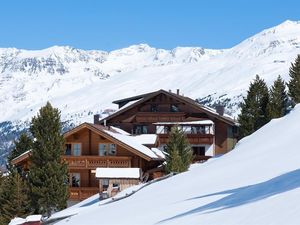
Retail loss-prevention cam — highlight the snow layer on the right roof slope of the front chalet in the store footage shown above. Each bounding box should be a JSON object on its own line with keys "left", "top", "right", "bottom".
{"left": 103, "top": 130, "right": 164, "bottom": 159}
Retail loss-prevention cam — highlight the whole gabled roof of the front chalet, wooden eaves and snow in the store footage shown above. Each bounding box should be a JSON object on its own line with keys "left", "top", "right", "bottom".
{"left": 64, "top": 123, "right": 163, "bottom": 161}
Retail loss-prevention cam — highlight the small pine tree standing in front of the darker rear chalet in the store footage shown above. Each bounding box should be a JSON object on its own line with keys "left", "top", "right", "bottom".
{"left": 166, "top": 126, "right": 193, "bottom": 173}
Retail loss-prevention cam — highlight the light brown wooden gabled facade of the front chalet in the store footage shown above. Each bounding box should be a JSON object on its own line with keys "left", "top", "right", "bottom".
{"left": 62, "top": 123, "right": 163, "bottom": 201}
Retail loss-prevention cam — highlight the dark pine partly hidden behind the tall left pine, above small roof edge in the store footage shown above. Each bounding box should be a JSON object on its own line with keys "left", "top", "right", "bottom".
{"left": 7, "top": 133, "right": 32, "bottom": 172}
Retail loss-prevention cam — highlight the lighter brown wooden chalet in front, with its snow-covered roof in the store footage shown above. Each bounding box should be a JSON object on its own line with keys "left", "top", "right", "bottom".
{"left": 12, "top": 123, "right": 164, "bottom": 201}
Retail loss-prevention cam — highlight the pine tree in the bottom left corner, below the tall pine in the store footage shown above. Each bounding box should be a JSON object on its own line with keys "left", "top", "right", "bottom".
{"left": 0, "top": 170, "right": 30, "bottom": 224}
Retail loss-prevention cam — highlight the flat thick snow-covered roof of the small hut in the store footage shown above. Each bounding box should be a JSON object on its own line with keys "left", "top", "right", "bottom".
{"left": 96, "top": 168, "right": 140, "bottom": 179}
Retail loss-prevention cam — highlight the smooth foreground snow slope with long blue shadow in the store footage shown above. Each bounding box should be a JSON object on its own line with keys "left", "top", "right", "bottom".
{"left": 58, "top": 105, "right": 300, "bottom": 225}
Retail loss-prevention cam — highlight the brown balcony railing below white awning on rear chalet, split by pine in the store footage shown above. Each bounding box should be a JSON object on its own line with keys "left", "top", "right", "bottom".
{"left": 158, "top": 134, "right": 214, "bottom": 145}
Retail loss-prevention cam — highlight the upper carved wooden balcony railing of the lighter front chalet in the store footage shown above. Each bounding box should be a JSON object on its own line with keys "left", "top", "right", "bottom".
{"left": 62, "top": 156, "right": 131, "bottom": 169}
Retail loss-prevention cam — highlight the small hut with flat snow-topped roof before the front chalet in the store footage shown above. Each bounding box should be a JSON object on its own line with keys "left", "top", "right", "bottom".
{"left": 96, "top": 168, "right": 141, "bottom": 199}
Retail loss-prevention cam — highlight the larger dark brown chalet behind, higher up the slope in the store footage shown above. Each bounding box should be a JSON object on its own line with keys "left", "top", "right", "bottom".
{"left": 94, "top": 90, "right": 237, "bottom": 160}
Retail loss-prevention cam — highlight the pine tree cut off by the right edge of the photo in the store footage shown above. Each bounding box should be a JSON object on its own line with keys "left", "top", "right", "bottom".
{"left": 288, "top": 55, "right": 300, "bottom": 104}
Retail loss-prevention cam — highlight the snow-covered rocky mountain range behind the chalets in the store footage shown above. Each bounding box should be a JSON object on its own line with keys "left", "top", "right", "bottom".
{"left": 0, "top": 21, "right": 300, "bottom": 123}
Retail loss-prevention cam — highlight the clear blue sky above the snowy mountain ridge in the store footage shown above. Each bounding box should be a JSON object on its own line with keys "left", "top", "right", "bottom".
{"left": 0, "top": 0, "right": 300, "bottom": 50}
